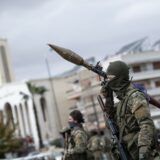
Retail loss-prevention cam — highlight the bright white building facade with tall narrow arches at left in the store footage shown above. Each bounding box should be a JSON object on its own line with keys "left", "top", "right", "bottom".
{"left": 0, "top": 82, "right": 39, "bottom": 148}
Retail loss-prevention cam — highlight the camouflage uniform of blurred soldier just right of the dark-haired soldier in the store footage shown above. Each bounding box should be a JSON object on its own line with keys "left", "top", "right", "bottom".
{"left": 87, "top": 135, "right": 103, "bottom": 160}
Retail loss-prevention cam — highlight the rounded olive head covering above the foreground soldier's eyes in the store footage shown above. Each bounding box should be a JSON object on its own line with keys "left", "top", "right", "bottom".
{"left": 107, "top": 61, "right": 129, "bottom": 78}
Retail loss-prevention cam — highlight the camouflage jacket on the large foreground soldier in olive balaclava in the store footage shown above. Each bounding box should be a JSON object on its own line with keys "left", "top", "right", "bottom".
{"left": 116, "top": 86, "right": 155, "bottom": 147}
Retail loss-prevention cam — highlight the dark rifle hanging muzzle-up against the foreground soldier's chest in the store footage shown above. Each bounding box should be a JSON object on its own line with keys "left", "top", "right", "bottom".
{"left": 97, "top": 95, "right": 129, "bottom": 160}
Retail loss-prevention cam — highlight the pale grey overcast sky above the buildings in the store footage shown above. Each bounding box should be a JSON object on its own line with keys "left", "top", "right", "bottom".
{"left": 0, "top": 0, "right": 160, "bottom": 80}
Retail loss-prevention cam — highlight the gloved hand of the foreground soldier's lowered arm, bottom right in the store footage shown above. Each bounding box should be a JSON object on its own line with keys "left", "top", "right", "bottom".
{"left": 139, "top": 146, "right": 150, "bottom": 160}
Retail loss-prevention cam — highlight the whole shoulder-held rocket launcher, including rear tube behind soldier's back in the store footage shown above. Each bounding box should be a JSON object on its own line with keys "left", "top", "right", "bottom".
{"left": 48, "top": 44, "right": 160, "bottom": 108}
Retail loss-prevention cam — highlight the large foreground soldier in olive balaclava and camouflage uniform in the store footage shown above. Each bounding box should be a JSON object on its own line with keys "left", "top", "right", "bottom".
{"left": 101, "top": 61, "right": 160, "bottom": 160}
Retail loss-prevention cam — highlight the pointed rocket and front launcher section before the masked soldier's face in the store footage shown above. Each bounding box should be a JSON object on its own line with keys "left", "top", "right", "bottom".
{"left": 48, "top": 44, "right": 107, "bottom": 79}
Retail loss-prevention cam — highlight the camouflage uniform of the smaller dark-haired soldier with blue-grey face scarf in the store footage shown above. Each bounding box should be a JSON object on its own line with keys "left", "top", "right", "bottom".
{"left": 68, "top": 125, "right": 88, "bottom": 160}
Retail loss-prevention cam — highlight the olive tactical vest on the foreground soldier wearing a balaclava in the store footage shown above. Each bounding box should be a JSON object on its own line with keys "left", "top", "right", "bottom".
{"left": 116, "top": 89, "right": 160, "bottom": 160}
